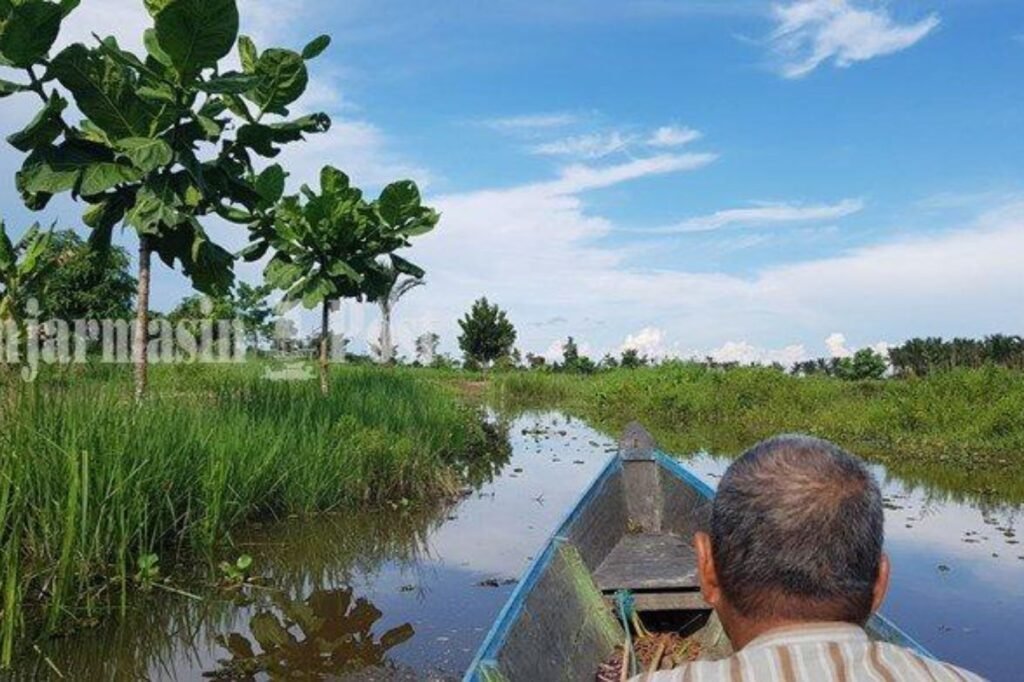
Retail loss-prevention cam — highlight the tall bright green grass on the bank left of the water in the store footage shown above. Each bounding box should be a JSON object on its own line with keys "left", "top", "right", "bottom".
{"left": 0, "top": 366, "right": 484, "bottom": 659}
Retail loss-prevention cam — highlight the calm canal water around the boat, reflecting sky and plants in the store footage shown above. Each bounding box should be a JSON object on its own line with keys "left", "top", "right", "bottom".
{"left": 13, "top": 414, "right": 1024, "bottom": 680}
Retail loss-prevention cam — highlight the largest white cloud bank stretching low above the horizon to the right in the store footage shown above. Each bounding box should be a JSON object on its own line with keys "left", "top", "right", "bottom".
{"left": 400, "top": 167, "right": 1024, "bottom": 364}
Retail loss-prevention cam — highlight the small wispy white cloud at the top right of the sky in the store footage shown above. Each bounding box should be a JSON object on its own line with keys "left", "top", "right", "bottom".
{"left": 771, "top": 0, "right": 939, "bottom": 78}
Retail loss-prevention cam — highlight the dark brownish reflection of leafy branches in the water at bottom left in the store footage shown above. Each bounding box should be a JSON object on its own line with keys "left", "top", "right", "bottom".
{"left": 206, "top": 588, "right": 414, "bottom": 680}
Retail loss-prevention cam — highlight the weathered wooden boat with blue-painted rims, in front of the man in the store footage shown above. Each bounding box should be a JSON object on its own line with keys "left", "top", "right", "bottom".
{"left": 464, "top": 424, "right": 931, "bottom": 682}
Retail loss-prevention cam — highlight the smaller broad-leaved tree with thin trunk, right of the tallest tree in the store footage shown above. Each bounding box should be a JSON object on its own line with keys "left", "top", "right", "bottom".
{"left": 260, "top": 166, "right": 439, "bottom": 395}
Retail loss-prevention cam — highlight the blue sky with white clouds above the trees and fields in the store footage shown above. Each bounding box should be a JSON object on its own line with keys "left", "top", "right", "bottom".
{"left": 0, "top": 0, "right": 1024, "bottom": 361}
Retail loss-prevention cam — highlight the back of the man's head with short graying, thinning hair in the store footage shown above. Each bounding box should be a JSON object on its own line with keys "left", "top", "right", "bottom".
{"left": 711, "top": 435, "right": 885, "bottom": 624}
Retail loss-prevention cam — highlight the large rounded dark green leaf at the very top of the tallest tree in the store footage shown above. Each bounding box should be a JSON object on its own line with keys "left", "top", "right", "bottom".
{"left": 156, "top": 0, "right": 239, "bottom": 78}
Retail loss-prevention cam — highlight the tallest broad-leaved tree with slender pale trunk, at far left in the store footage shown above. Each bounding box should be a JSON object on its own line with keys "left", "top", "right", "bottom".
{"left": 0, "top": 0, "right": 331, "bottom": 398}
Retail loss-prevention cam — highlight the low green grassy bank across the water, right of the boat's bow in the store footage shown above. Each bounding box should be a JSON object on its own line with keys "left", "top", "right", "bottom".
{"left": 489, "top": 365, "right": 1024, "bottom": 502}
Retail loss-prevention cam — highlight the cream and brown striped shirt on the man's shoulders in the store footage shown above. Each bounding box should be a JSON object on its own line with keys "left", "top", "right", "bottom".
{"left": 632, "top": 623, "right": 982, "bottom": 682}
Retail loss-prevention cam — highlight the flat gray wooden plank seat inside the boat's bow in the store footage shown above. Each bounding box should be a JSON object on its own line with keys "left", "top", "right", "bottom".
{"left": 594, "top": 532, "right": 697, "bottom": 592}
